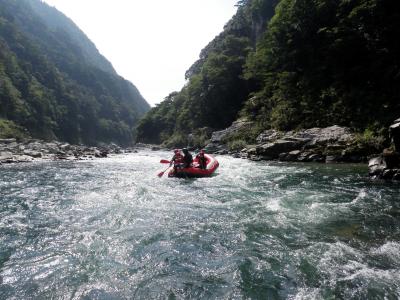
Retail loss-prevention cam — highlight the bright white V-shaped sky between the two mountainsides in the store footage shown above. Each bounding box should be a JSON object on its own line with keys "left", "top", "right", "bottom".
{"left": 44, "top": 0, "right": 237, "bottom": 105}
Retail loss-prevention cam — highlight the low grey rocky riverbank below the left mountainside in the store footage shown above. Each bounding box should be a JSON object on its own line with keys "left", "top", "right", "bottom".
{"left": 0, "top": 139, "right": 135, "bottom": 164}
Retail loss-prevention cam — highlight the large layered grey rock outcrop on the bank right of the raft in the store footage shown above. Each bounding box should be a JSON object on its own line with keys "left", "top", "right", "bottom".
{"left": 206, "top": 121, "right": 374, "bottom": 163}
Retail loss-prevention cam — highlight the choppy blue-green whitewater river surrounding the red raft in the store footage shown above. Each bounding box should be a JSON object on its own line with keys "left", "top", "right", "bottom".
{"left": 0, "top": 151, "right": 400, "bottom": 299}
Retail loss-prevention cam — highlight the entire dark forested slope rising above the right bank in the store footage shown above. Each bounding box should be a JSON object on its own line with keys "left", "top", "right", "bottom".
{"left": 138, "top": 0, "right": 400, "bottom": 145}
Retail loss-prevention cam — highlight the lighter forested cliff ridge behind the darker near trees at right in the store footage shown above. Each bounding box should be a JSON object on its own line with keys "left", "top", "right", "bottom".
{"left": 138, "top": 0, "right": 278, "bottom": 145}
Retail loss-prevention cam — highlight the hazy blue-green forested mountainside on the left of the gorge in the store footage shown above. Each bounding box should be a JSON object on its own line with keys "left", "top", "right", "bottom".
{"left": 0, "top": 0, "right": 150, "bottom": 145}
